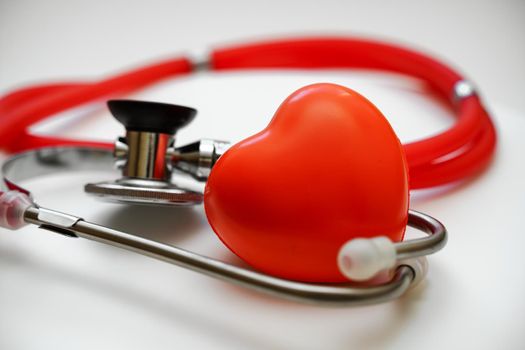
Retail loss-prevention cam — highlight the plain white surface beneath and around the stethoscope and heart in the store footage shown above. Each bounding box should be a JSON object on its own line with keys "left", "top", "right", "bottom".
{"left": 0, "top": 1, "right": 525, "bottom": 349}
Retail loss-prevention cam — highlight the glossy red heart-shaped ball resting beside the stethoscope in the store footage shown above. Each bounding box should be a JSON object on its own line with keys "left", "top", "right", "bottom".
{"left": 204, "top": 84, "right": 408, "bottom": 282}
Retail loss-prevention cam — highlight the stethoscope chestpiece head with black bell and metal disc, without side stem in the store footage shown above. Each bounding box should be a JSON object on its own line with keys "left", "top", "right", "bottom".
{"left": 105, "top": 100, "right": 202, "bottom": 198}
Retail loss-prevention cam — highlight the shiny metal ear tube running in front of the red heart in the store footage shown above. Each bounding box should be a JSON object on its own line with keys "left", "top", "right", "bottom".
{"left": 24, "top": 206, "right": 447, "bottom": 306}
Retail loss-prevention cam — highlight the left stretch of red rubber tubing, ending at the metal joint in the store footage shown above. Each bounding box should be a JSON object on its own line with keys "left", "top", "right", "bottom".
{"left": 0, "top": 58, "right": 192, "bottom": 152}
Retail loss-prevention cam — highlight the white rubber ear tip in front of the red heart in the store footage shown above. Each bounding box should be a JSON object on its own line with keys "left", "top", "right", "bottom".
{"left": 337, "top": 236, "right": 396, "bottom": 281}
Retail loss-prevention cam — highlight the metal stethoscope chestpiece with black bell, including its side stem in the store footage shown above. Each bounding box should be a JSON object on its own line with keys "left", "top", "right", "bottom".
{"left": 85, "top": 100, "right": 229, "bottom": 205}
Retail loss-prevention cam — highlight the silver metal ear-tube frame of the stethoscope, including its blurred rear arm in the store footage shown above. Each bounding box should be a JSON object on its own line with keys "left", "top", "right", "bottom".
{"left": 0, "top": 142, "right": 447, "bottom": 306}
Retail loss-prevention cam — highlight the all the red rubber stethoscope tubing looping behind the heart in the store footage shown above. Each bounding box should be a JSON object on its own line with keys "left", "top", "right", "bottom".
{"left": 0, "top": 37, "right": 496, "bottom": 189}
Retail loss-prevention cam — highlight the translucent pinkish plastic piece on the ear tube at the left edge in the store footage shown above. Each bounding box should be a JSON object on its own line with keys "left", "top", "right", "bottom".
{"left": 0, "top": 191, "right": 34, "bottom": 230}
